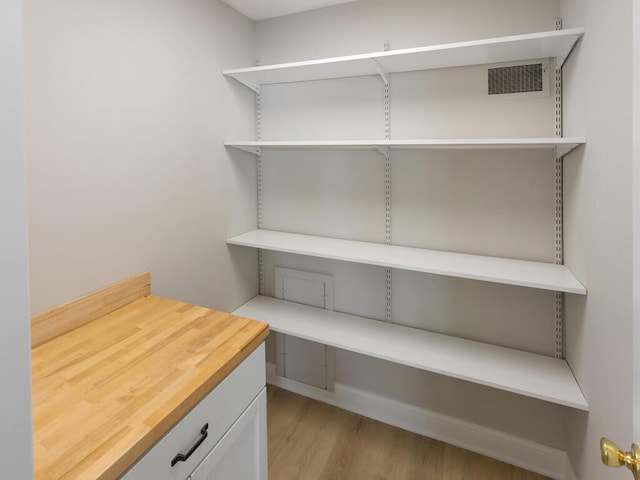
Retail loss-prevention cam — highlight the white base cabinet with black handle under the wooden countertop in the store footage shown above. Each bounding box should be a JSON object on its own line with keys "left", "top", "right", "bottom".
{"left": 121, "top": 344, "right": 267, "bottom": 480}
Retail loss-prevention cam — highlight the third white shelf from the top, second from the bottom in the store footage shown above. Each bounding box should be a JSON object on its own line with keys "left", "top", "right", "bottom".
{"left": 227, "top": 230, "right": 587, "bottom": 295}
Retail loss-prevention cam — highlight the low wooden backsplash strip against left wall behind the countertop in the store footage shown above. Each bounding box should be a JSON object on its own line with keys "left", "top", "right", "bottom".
{"left": 31, "top": 272, "right": 151, "bottom": 348}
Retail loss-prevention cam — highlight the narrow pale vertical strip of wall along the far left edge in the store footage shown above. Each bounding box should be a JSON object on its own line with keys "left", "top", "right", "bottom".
{"left": 0, "top": 0, "right": 33, "bottom": 479}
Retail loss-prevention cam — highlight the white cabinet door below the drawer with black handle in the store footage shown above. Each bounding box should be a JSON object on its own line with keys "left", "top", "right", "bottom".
{"left": 189, "top": 389, "right": 267, "bottom": 480}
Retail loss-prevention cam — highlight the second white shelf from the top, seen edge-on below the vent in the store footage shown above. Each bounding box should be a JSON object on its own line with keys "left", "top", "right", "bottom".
{"left": 224, "top": 138, "right": 586, "bottom": 158}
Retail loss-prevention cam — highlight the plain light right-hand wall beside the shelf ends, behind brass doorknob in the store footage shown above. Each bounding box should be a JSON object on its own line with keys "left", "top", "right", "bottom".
{"left": 562, "top": 0, "right": 640, "bottom": 480}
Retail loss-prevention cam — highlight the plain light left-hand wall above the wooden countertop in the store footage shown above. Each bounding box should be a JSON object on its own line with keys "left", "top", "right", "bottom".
{"left": 24, "top": 0, "right": 257, "bottom": 313}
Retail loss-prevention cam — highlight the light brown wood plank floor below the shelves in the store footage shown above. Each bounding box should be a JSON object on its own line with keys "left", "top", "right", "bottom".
{"left": 267, "top": 385, "right": 546, "bottom": 480}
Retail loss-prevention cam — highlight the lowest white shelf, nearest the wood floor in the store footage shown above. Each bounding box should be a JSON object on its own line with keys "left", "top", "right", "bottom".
{"left": 233, "top": 296, "right": 589, "bottom": 411}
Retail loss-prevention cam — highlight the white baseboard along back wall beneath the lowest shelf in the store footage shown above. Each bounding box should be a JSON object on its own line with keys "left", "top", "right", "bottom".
{"left": 267, "top": 363, "right": 575, "bottom": 480}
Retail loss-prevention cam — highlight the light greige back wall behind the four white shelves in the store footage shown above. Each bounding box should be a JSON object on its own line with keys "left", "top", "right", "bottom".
{"left": 249, "top": 0, "right": 568, "bottom": 449}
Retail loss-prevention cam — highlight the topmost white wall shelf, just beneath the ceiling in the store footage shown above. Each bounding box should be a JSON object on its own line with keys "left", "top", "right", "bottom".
{"left": 222, "top": 28, "right": 584, "bottom": 91}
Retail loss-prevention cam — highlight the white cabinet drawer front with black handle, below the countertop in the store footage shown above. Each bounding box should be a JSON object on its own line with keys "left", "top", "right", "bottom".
{"left": 121, "top": 343, "right": 266, "bottom": 480}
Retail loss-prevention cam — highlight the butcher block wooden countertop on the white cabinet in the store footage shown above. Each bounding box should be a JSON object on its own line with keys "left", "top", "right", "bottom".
{"left": 32, "top": 274, "right": 268, "bottom": 480}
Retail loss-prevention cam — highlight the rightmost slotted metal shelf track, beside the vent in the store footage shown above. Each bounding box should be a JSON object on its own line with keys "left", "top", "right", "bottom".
{"left": 554, "top": 19, "right": 564, "bottom": 359}
